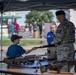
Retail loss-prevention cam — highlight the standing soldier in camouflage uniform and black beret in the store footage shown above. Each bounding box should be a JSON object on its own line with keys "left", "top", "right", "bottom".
{"left": 51, "top": 10, "right": 75, "bottom": 71}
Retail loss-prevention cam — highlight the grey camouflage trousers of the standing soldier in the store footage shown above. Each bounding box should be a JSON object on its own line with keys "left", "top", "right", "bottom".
{"left": 57, "top": 43, "right": 74, "bottom": 72}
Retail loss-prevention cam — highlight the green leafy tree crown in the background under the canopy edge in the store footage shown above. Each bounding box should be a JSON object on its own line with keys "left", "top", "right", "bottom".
{"left": 25, "top": 10, "right": 54, "bottom": 23}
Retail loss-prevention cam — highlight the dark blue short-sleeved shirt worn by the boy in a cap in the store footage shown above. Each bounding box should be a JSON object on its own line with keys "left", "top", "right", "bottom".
{"left": 6, "top": 44, "right": 26, "bottom": 58}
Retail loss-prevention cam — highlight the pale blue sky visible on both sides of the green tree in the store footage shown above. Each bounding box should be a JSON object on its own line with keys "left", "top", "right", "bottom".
{"left": 17, "top": 10, "right": 56, "bottom": 26}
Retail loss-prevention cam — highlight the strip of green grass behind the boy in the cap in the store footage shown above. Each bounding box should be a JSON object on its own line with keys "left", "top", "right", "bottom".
{"left": 2, "top": 39, "right": 44, "bottom": 46}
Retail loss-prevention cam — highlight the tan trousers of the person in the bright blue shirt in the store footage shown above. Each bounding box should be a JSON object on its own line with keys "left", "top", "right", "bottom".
{"left": 47, "top": 47, "right": 57, "bottom": 59}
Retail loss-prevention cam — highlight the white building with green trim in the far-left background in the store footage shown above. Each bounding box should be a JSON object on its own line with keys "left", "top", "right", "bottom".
{"left": 0, "top": 11, "right": 21, "bottom": 40}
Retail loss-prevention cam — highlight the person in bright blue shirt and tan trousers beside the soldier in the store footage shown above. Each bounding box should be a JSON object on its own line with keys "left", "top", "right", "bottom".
{"left": 47, "top": 23, "right": 57, "bottom": 59}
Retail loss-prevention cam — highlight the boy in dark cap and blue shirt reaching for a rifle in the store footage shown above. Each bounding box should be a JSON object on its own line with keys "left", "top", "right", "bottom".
{"left": 6, "top": 35, "right": 36, "bottom": 58}
